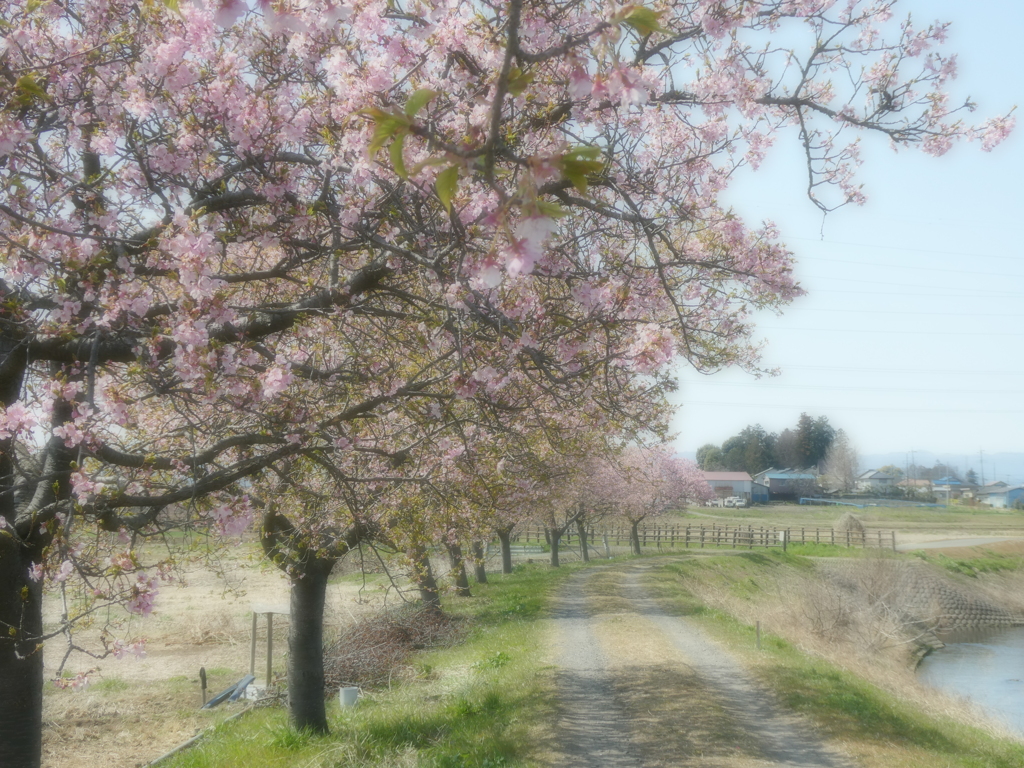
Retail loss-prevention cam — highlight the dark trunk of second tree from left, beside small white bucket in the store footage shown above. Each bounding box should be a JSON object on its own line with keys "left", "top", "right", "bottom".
{"left": 288, "top": 560, "right": 334, "bottom": 733}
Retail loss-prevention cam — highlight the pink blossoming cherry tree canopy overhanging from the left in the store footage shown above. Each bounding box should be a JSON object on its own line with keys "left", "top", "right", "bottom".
{"left": 0, "top": 0, "right": 1011, "bottom": 768}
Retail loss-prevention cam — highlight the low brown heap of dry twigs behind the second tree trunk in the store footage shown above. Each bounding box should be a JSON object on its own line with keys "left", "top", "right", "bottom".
{"left": 324, "top": 606, "right": 464, "bottom": 691}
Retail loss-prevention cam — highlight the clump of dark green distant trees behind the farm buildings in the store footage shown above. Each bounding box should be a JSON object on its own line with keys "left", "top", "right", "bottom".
{"left": 697, "top": 414, "right": 836, "bottom": 475}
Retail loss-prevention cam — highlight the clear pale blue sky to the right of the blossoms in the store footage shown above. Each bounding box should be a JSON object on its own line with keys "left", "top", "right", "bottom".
{"left": 674, "top": 0, "right": 1024, "bottom": 462}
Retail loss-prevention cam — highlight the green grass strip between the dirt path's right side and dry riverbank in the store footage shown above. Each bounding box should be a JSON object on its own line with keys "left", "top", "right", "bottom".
{"left": 649, "top": 560, "right": 1024, "bottom": 768}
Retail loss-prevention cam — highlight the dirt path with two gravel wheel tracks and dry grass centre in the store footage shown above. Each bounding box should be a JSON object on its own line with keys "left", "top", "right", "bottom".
{"left": 553, "top": 566, "right": 853, "bottom": 768}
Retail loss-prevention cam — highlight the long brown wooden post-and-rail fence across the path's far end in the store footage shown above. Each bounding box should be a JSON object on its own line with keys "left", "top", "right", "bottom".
{"left": 512, "top": 524, "right": 896, "bottom": 551}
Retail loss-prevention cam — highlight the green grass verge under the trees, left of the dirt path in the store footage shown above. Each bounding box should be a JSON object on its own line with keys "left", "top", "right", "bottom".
{"left": 166, "top": 564, "right": 579, "bottom": 768}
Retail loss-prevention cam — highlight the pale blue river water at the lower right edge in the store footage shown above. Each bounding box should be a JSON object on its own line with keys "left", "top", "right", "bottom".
{"left": 918, "top": 627, "right": 1024, "bottom": 735}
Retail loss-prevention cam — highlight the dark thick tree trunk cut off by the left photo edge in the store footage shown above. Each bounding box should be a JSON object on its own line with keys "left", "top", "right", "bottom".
{"left": 0, "top": 536, "right": 43, "bottom": 768}
